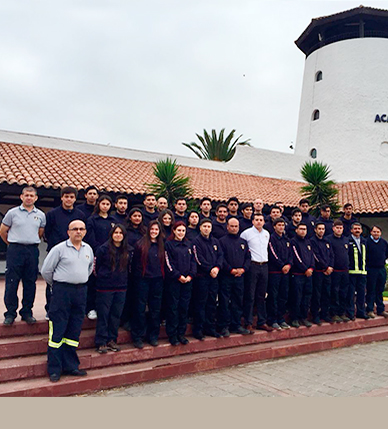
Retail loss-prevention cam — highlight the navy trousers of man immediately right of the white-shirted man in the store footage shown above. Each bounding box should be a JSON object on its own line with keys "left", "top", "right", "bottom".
{"left": 266, "top": 273, "right": 289, "bottom": 325}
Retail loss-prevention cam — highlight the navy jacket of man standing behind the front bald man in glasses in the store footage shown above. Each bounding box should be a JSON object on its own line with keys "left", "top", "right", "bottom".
{"left": 44, "top": 204, "right": 86, "bottom": 252}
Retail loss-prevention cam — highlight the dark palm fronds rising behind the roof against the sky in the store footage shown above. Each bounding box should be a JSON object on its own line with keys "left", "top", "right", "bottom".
{"left": 182, "top": 128, "right": 250, "bottom": 162}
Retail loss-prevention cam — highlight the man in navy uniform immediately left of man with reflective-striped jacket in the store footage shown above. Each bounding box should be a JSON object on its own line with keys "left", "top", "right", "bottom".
{"left": 328, "top": 220, "right": 350, "bottom": 323}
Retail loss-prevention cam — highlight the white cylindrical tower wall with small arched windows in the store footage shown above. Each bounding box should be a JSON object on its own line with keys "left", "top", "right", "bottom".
{"left": 295, "top": 38, "right": 388, "bottom": 181}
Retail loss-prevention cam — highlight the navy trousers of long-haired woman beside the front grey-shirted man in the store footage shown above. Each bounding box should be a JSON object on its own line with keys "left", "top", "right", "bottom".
{"left": 94, "top": 290, "right": 126, "bottom": 347}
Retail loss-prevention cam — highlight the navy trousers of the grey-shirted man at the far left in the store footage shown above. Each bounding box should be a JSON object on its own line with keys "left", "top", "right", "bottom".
{"left": 4, "top": 243, "right": 39, "bottom": 318}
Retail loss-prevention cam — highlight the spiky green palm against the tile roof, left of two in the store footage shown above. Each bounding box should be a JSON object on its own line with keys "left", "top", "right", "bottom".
{"left": 146, "top": 158, "right": 193, "bottom": 207}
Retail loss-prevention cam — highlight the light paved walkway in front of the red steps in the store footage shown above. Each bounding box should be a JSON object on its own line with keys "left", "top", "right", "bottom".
{"left": 87, "top": 341, "right": 388, "bottom": 397}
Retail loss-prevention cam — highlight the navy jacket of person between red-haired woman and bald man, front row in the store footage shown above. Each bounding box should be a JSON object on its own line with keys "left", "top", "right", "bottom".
{"left": 192, "top": 234, "right": 224, "bottom": 277}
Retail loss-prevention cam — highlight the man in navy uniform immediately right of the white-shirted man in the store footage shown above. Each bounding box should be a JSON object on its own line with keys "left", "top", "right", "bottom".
{"left": 267, "top": 218, "right": 292, "bottom": 330}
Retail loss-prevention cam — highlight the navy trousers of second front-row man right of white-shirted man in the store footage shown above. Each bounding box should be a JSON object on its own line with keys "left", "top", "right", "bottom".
{"left": 290, "top": 275, "right": 313, "bottom": 320}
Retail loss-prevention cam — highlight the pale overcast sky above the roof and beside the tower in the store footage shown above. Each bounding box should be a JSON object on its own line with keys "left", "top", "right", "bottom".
{"left": 0, "top": 0, "right": 388, "bottom": 156}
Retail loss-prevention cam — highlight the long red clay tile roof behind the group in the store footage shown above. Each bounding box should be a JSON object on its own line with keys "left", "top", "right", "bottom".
{"left": 0, "top": 143, "right": 388, "bottom": 213}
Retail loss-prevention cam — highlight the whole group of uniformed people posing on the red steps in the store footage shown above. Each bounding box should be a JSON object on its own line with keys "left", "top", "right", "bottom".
{"left": 0, "top": 186, "right": 388, "bottom": 382}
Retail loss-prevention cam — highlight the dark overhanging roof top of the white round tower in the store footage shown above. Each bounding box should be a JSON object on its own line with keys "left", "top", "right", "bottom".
{"left": 295, "top": 5, "right": 388, "bottom": 57}
